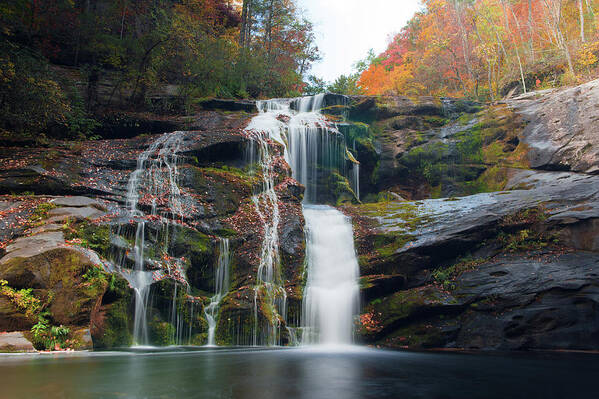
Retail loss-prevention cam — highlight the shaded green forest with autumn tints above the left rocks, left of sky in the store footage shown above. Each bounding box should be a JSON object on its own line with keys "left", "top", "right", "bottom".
{"left": 0, "top": 0, "right": 319, "bottom": 139}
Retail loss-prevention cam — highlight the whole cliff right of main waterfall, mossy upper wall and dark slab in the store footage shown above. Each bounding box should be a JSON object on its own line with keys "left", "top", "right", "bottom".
{"left": 344, "top": 81, "right": 599, "bottom": 350}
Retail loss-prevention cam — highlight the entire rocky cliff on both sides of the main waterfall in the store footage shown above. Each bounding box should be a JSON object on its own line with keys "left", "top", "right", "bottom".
{"left": 0, "top": 81, "right": 599, "bottom": 350}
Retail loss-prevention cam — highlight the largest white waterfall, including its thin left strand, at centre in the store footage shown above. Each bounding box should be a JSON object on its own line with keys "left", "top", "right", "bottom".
{"left": 246, "top": 95, "right": 359, "bottom": 345}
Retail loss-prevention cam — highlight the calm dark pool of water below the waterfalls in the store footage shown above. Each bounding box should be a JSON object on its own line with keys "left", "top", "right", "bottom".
{"left": 0, "top": 347, "right": 599, "bottom": 399}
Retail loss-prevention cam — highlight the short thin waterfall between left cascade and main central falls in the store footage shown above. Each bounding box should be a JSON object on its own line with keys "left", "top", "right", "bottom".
{"left": 204, "top": 238, "right": 231, "bottom": 346}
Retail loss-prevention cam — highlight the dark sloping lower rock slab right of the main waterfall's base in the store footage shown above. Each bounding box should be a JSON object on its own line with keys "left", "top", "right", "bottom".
{"left": 346, "top": 171, "right": 599, "bottom": 349}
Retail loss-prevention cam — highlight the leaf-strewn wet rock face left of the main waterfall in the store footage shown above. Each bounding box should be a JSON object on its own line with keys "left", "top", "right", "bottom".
{"left": 0, "top": 104, "right": 304, "bottom": 348}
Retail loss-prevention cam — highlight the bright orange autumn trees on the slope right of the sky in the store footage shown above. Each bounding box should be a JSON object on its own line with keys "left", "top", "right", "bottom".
{"left": 359, "top": 0, "right": 599, "bottom": 99}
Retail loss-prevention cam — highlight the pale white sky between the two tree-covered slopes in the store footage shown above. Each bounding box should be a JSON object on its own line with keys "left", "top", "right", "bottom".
{"left": 298, "top": 0, "right": 420, "bottom": 81}
